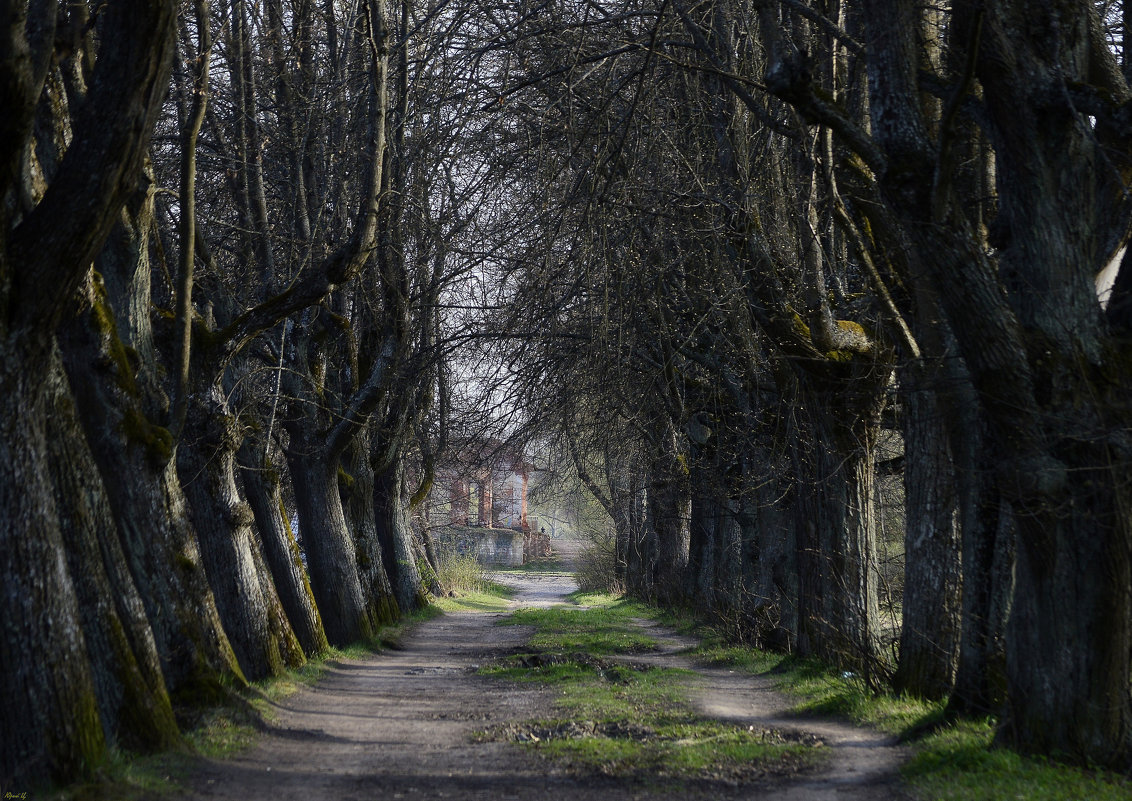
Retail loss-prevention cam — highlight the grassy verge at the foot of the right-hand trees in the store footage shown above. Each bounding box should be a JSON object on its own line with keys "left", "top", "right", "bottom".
{"left": 683, "top": 630, "right": 1132, "bottom": 801}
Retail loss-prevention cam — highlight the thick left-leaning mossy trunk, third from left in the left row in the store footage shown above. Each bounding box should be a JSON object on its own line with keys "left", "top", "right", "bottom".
{"left": 60, "top": 273, "right": 243, "bottom": 705}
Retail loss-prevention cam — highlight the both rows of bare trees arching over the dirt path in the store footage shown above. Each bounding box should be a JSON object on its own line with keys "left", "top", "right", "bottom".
{"left": 0, "top": 0, "right": 1132, "bottom": 787}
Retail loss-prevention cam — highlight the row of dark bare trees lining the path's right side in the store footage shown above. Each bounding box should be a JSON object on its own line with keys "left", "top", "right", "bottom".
{"left": 491, "top": 0, "right": 1132, "bottom": 767}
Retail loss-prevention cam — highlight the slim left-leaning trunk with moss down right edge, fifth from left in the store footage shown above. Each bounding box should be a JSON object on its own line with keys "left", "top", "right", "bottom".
{"left": 240, "top": 442, "right": 327, "bottom": 656}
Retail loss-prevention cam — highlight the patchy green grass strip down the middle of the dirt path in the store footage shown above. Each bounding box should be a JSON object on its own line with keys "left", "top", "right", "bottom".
{"left": 481, "top": 593, "right": 815, "bottom": 782}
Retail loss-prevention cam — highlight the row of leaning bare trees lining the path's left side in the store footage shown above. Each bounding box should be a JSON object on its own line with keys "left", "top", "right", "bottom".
{"left": 0, "top": 0, "right": 504, "bottom": 786}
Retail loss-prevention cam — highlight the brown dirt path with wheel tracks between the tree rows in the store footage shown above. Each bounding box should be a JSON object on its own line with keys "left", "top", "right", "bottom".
{"left": 181, "top": 554, "right": 900, "bottom": 801}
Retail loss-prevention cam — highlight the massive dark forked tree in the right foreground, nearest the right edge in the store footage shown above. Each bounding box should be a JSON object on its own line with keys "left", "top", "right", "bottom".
{"left": 866, "top": 0, "right": 1132, "bottom": 768}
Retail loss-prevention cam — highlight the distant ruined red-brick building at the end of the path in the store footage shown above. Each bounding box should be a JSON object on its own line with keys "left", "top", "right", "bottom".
{"left": 436, "top": 438, "right": 532, "bottom": 532}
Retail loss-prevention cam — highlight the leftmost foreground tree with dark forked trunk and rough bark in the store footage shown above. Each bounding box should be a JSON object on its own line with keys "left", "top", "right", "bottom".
{"left": 0, "top": 2, "right": 175, "bottom": 781}
